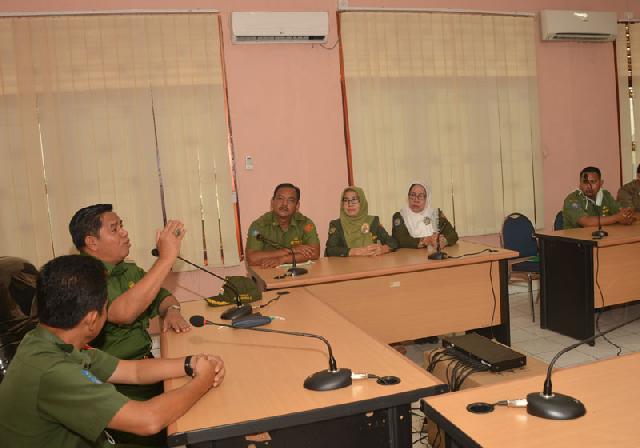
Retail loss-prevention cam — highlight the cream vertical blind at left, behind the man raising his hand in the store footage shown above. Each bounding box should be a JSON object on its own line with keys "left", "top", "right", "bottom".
{"left": 0, "top": 14, "right": 239, "bottom": 266}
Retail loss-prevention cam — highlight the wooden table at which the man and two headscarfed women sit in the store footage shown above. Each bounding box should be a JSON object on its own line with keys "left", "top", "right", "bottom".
{"left": 249, "top": 241, "right": 518, "bottom": 345}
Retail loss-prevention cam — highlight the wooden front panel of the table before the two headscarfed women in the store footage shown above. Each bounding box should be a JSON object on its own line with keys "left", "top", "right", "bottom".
{"left": 306, "top": 262, "right": 501, "bottom": 343}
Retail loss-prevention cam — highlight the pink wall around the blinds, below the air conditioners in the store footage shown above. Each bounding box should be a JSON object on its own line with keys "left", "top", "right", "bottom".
{"left": 0, "top": 0, "right": 640, "bottom": 296}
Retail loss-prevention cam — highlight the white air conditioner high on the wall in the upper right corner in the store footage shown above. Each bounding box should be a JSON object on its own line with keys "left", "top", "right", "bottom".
{"left": 540, "top": 10, "right": 618, "bottom": 42}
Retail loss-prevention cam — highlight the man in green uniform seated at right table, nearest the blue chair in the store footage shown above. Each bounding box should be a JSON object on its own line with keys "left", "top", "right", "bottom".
{"left": 562, "top": 166, "right": 634, "bottom": 229}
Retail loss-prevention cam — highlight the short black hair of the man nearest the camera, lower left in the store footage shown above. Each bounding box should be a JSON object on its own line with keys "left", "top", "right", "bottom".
{"left": 36, "top": 255, "right": 107, "bottom": 330}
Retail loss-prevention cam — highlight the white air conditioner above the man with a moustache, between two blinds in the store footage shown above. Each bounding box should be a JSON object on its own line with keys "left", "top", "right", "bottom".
{"left": 231, "top": 11, "right": 329, "bottom": 44}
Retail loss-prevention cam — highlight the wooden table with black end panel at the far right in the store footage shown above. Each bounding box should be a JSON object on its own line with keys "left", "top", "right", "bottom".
{"left": 536, "top": 222, "right": 640, "bottom": 339}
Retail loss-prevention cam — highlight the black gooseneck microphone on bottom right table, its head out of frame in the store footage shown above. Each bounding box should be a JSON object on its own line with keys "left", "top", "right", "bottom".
{"left": 527, "top": 316, "right": 640, "bottom": 420}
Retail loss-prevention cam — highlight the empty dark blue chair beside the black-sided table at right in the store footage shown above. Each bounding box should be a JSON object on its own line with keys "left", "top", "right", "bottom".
{"left": 500, "top": 213, "right": 540, "bottom": 322}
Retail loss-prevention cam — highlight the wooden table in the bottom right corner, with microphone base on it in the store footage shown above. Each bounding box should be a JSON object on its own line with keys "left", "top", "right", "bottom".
{"left": 422, "top": 353, "right": 640, "bottom": 448}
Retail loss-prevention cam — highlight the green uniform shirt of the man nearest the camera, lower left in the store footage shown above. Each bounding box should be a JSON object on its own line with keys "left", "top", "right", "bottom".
{"left": 0, "top": 326, "right": 128, "bottom": 448}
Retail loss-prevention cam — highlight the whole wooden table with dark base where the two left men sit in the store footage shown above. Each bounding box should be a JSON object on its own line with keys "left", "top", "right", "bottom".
{"left": 161, "top": 289, "right": 446, "bottom": 447}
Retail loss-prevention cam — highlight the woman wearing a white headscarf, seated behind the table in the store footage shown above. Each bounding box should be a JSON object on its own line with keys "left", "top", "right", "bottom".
{"left": 391, "top": 182, "right": 458, "bottom": 249}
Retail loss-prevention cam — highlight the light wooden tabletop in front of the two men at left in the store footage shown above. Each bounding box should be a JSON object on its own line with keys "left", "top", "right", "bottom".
{"left": 161, "top": 288, "right": 442, "bottom": 439}
